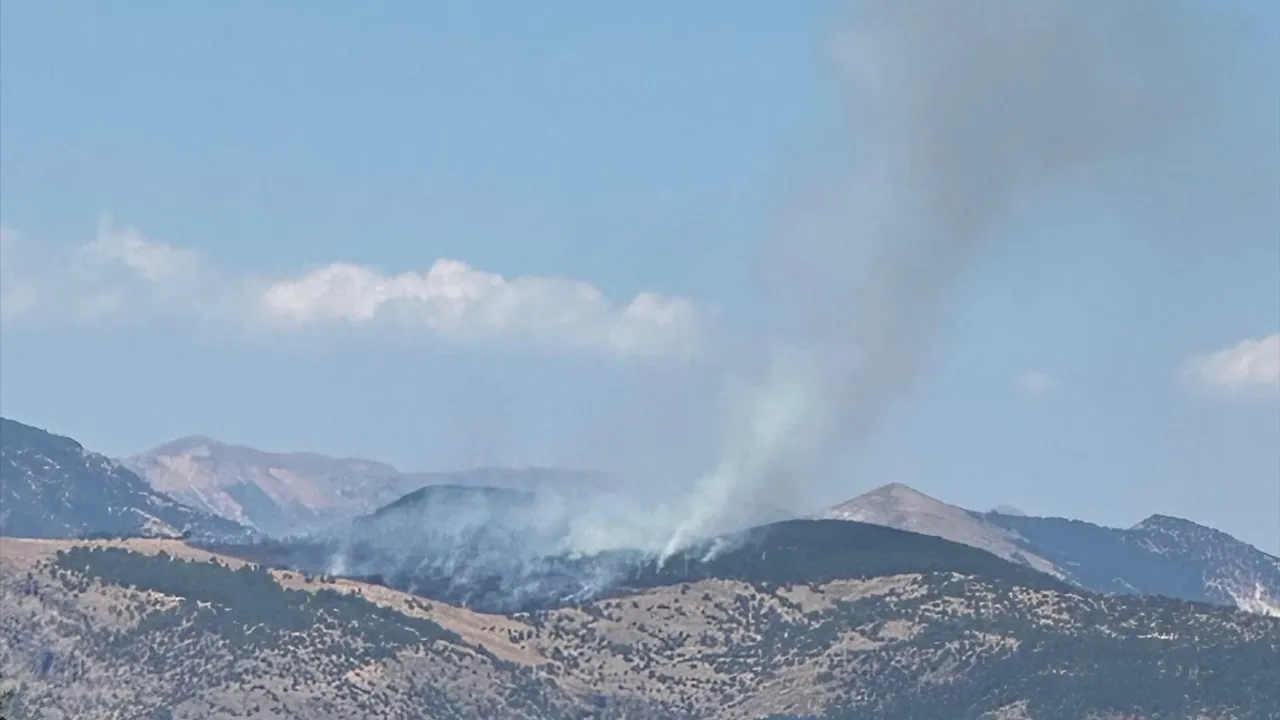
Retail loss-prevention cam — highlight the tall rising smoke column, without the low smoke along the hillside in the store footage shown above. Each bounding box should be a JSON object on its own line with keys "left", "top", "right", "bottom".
{"left": 667, "top": 0, "right": 1224, "bottom": 551}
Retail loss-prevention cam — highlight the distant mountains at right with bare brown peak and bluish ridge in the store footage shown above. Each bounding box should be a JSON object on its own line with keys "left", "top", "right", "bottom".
{"left": 822, "top": 484, "right": 1280, "bottom": 615}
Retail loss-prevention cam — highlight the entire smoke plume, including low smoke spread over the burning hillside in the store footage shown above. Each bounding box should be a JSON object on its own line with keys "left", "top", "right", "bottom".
{"left": 288, "top": 0, "right": 1249, "bottom": 609}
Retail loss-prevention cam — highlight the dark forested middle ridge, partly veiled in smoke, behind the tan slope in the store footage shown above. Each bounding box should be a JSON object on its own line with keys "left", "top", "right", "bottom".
{"left": 212, "top": 512, "right": 1069, "bottom": 612}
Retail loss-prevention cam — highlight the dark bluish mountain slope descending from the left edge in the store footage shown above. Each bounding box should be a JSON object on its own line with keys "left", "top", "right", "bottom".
{"left": 0, "top": 418, "right": 244, "bottom": 538}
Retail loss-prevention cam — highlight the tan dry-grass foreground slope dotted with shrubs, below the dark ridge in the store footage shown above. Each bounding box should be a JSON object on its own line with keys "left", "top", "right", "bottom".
{"left": 0, "top": 538, "right": 1280, "bottom": 720}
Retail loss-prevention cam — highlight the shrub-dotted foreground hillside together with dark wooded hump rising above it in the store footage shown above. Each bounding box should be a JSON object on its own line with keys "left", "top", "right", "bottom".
{"left": 0, "top": 530, "right": 1280, "bottom": 720}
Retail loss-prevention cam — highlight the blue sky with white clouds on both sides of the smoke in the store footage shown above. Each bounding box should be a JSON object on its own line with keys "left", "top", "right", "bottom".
{"left": 0, "top": 1, "right": 1280, "bottom": 551}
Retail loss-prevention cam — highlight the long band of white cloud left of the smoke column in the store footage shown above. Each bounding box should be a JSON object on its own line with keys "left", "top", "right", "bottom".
{"left": 0, "top": 217, "right": 705, "bottom": 357}
